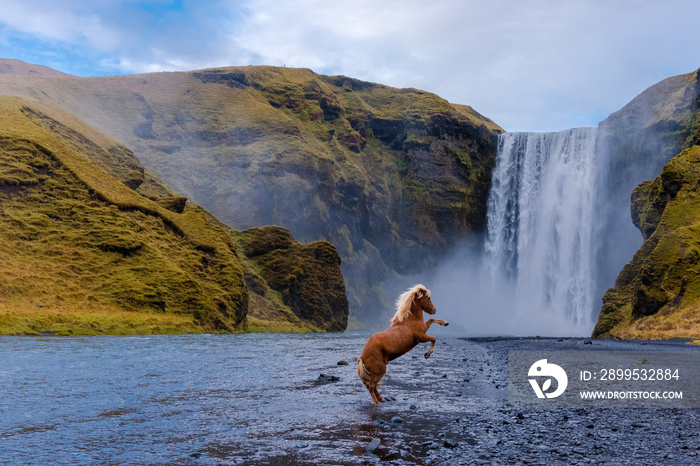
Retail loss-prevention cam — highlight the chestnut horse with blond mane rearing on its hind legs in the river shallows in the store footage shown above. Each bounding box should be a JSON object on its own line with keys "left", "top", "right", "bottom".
{"left": 357, "top": 285, "right": 449, "bottom": 404}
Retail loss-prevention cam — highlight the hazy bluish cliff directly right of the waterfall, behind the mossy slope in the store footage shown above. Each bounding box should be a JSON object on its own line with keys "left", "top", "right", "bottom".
{"left": 597, "top": 73, "right": 697, "bottom": 302}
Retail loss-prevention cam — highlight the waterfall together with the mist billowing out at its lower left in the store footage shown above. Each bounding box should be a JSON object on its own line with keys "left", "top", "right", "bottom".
{"left": 433, "top": 128, "right": 605, "bottom": 336}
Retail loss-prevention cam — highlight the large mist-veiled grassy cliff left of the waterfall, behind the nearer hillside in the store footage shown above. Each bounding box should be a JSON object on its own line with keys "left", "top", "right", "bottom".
{"left": 0, "top": 62, "right": 501, "bottom": 321}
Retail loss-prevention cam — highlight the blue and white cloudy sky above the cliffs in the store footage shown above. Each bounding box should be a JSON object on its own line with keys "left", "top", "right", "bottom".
{"left": 0, "top": 0, "right": 700, "bottom": 131}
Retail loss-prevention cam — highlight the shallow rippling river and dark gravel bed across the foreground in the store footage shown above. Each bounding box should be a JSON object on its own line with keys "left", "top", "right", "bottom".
{"left": 0, "top": 330, "right": 700, "bottom": 465}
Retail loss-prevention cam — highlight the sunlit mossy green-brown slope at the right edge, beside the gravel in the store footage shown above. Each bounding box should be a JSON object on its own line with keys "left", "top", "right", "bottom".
{"left": 593, "top": 146, "right": 700, "bottom": 338}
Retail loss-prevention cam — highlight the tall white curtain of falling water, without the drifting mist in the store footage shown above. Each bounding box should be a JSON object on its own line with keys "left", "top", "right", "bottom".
{"left": 484, "top": 128, "right": 600, "bottom": 335}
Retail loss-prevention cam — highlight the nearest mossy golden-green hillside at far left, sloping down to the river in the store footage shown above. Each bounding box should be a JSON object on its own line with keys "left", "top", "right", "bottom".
{"left": 0, "top": 98, "right": 247, "bottom": 334}
